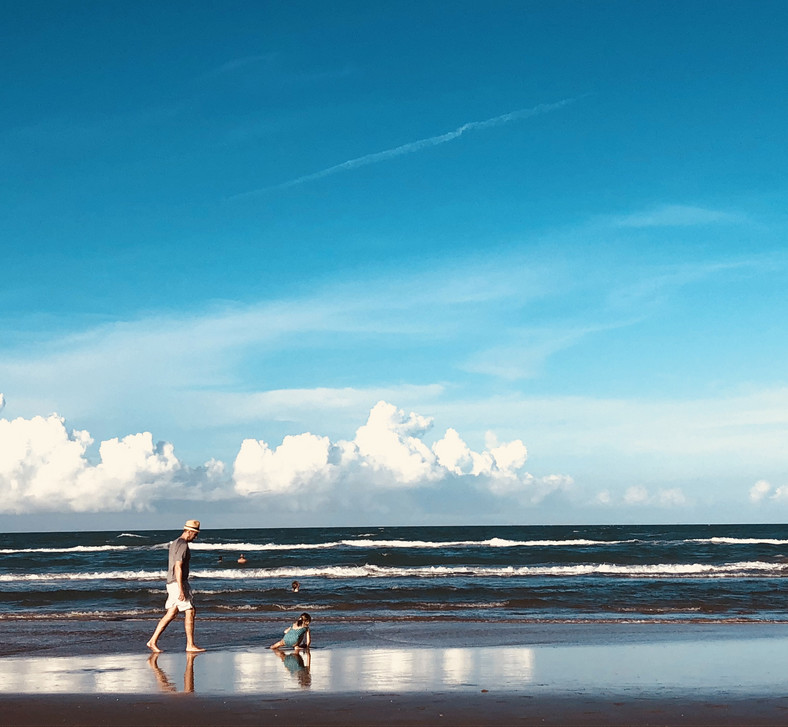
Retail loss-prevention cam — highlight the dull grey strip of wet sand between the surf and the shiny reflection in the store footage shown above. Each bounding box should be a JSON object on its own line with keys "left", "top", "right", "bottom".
{"left": 0, "top": 611, "right": 788, "bottom": 660}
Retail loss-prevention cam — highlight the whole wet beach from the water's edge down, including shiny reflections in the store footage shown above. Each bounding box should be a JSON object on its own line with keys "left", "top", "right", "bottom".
{"left": 0, "top": 619, "right": 788, "bottom": 725}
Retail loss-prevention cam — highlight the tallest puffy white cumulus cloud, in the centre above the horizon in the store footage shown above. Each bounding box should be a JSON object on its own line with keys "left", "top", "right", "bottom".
{"left": 233, "top": 401, "right": 573, "bottom": 502}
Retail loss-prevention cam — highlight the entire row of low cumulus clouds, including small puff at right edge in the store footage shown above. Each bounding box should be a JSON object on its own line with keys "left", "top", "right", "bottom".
{"left": 0, "top": 395, "right": 776, "bottom": 522}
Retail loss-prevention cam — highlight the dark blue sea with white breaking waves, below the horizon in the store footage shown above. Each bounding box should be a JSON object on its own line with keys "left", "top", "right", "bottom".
{"left": 0, "top": 525, "right": 788, "bottom": 622}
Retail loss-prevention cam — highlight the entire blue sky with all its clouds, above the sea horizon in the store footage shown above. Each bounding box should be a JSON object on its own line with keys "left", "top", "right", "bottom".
{"left": 0, "top": 0, "right": 788, "bottom": 529}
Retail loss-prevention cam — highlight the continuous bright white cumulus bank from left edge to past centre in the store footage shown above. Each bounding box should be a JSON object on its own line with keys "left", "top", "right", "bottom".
{"left": 0, "top": 401, "right": 573, "bottom": 514}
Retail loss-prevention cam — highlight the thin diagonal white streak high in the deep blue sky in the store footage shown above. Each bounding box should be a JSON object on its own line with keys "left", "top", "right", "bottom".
{"left": 230, "top": 98, "right": 576, "bottom": 199}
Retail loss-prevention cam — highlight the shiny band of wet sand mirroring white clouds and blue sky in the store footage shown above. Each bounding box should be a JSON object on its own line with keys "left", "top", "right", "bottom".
{"left": 0, "top": 638, "right": 788, "bottom": 695}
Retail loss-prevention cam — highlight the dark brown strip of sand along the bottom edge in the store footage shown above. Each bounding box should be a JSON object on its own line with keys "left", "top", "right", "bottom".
{"left": 0, "top": 693, "right": 788, "bottom": 727}
